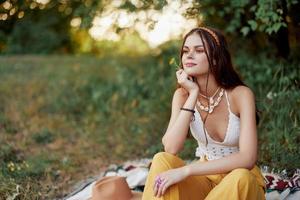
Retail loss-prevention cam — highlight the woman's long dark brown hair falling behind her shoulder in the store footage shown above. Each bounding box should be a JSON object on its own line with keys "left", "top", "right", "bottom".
{"left": 180, "top": 27, "right": 259, "bottom": 145}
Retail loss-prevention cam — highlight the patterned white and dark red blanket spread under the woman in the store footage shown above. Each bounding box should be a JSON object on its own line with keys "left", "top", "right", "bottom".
{"left": 64, "top": 159, "right": 300, "bottom": 200}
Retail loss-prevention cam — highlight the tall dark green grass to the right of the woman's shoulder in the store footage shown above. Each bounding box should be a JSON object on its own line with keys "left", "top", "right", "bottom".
{"left": 236, "top": 52, "right": 300, "bottom": 171}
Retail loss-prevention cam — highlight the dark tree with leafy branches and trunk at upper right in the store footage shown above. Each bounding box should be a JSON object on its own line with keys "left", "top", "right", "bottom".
{"left": 187, "top": 0, "right": 300, "bottom": 58}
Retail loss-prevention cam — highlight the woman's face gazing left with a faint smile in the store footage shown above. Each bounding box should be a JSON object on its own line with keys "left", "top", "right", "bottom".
{"left": 181, "top": 33, "right": 209, "bottom": 76}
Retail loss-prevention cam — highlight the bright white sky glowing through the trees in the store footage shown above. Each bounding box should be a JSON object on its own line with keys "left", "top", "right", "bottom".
{"left": 87, "top": 0, "right": 197, "bottom": 48}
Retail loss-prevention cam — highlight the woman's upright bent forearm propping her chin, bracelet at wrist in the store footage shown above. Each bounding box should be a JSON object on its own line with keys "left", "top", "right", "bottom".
{"left": 162, "top": 72, "right": 199, "bottom": 155}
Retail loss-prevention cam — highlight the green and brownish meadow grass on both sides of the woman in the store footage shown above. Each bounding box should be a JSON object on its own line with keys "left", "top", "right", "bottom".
{"left": 0, "top": 50, "right": 300, "bottom": 200}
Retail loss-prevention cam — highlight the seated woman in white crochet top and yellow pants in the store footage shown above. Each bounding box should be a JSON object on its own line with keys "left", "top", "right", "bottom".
{"left": 143, "top": 27, "right": 265, "bottom": 200}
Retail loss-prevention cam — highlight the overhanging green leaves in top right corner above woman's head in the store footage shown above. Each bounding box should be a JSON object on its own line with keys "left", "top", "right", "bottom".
{"left": 186, "top": 0, "right": 298, "bottom": 36}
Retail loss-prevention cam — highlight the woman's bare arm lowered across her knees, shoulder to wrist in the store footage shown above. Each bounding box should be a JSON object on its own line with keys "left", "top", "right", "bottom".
{"left": 182, "top": 86, "right": 257, "bottom": 176}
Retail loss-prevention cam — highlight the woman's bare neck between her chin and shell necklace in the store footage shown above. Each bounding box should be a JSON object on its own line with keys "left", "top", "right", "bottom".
{"left": 196, "top": 74, "right": 220, "bottom": 97}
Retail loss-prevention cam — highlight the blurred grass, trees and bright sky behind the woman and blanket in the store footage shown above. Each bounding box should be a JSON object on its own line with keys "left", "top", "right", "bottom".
{"left": 0, "top": 0, "right": 300, "bottom": 199}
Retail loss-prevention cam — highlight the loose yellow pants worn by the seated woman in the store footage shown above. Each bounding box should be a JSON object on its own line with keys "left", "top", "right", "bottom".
{"left": 142, "top": 152, "right": 265, "bottom": 200}
